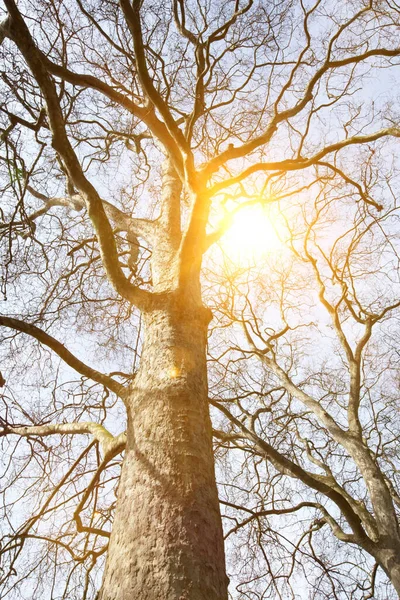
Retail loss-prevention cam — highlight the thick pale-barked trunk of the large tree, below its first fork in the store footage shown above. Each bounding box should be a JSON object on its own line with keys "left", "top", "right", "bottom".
{"left": 100, "top": 305, "right": 227, "bottom": 600}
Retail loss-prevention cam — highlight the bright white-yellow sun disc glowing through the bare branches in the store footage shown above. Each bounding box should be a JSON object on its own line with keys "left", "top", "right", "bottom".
{"left": 221, "top": 204, "right": 283, "bottom": 264}
